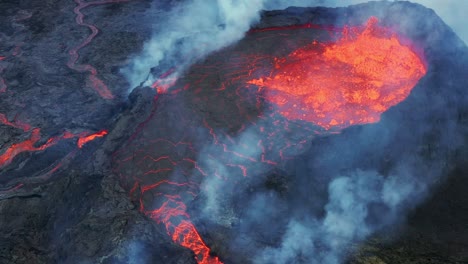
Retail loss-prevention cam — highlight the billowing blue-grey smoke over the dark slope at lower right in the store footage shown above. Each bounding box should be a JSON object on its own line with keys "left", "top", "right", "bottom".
{"left": 255, "top": 170, "right": 426, "bottom": 264}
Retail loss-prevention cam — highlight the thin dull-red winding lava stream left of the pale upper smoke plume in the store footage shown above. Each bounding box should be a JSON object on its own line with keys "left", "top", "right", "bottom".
{"left": 67, "top": 0, "right": 130, "bottom": 99}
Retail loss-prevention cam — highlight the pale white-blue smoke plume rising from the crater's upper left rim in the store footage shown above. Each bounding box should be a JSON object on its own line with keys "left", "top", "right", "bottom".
{"left": 123, "top": 0, "right": 264, "bottom": 88}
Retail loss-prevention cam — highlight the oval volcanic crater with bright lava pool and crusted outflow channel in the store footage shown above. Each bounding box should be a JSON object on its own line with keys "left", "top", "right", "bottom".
{"left": 114, "top": 4, "right": 432, "bottom": 264}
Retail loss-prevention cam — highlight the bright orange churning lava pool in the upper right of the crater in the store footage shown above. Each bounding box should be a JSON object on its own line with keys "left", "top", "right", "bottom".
{"left": 248, "top": 17, "right": 426, "bottom": 130}
